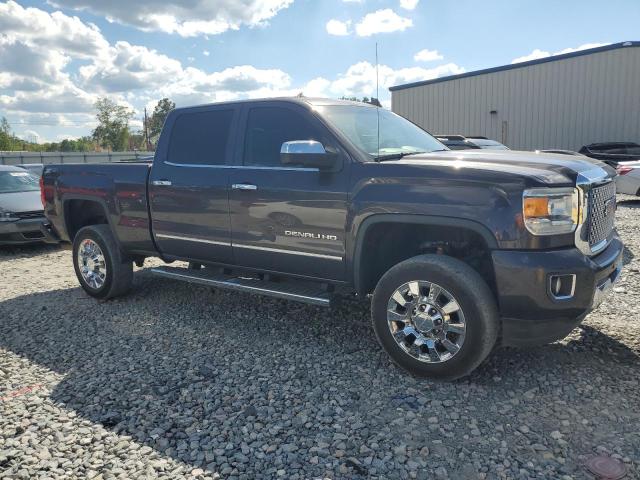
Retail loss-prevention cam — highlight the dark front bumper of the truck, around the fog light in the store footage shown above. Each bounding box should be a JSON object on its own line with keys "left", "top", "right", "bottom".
{"left": 492, "top": 234, "right": 624, "bottom": 346}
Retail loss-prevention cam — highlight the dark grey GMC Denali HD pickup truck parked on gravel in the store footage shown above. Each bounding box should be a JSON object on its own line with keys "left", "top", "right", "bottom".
{"left": 42, "top": 98, "right": 623, "bottom": 379}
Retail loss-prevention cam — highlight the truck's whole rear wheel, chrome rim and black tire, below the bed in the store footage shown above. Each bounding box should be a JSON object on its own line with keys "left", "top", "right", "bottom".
{"left": 73, "top": 225, "right": 133, "bottom": 300}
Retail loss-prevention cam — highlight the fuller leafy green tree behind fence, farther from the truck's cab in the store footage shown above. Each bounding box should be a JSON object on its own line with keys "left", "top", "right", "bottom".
{"left": 92, "top": 97, "right": 133, "bottom": 151}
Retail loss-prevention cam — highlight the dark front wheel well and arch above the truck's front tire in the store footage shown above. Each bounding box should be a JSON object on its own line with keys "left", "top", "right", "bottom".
{"left": 352, "top": 214, "right": 498, "bottom": 296}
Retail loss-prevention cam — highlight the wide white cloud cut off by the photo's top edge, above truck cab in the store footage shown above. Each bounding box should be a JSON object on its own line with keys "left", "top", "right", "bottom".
{"left": 51, "top": 0, "right": 293, "bottom": 37}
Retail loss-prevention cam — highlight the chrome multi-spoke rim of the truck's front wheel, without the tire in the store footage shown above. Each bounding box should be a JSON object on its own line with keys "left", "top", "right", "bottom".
{"left": 387, "top": 280, "right": 467, "bottom": 363}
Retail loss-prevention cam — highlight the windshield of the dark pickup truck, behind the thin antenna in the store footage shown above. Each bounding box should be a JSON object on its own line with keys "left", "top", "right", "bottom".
{"left": 317, "top": 105, "right": 447, "bottom": 158}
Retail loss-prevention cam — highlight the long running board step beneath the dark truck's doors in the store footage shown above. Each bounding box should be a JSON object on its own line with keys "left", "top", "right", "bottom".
{"left": 151, "top": 267, "right": 331, "bottom": 307}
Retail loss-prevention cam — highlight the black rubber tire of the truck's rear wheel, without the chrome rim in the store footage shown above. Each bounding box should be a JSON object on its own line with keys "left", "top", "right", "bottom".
{"left": 73, "top": 225, "right": 133, "bottom": 300}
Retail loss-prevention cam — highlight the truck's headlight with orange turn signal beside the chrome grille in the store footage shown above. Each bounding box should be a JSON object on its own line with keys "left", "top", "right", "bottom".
{"left": 522, "top": 188, "right": 580, "bottom": 235}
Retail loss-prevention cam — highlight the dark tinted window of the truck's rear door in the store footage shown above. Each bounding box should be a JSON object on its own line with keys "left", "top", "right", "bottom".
{"left": 168, "top": 109, "right": 235, "bottom": 165}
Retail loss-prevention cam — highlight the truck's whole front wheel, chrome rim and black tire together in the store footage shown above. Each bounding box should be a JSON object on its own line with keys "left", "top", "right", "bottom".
{"left": 372, "top": 255, "right": 499, "bottom": 380}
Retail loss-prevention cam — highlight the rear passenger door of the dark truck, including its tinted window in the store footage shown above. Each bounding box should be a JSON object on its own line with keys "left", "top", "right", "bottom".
{"left": 149, "top": 105, "right": 238, "bottom": 263}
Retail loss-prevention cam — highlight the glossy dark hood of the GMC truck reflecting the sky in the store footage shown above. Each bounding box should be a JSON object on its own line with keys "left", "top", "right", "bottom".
{"left": 390, "top": 150, "right": 615, "bottom": 184}
